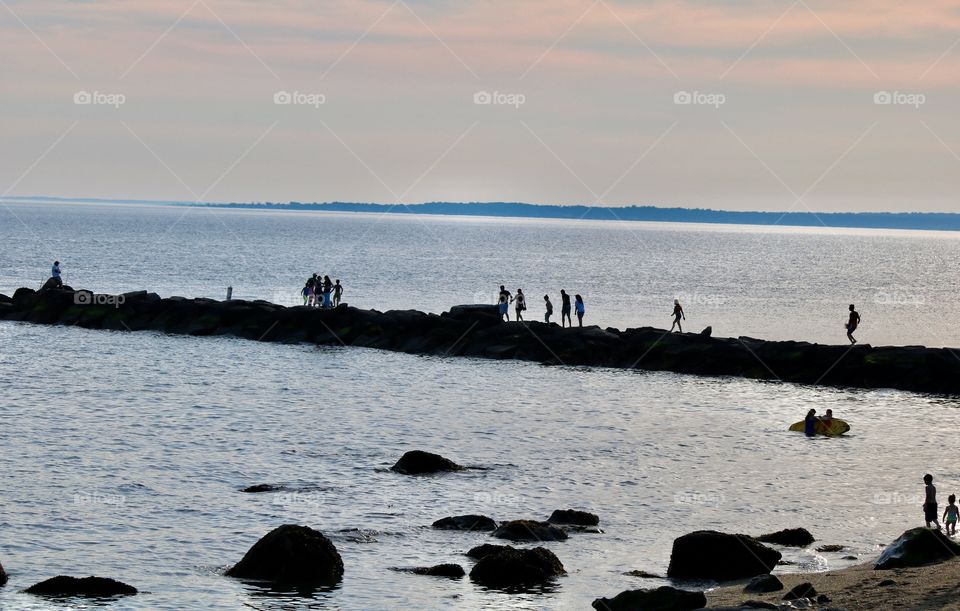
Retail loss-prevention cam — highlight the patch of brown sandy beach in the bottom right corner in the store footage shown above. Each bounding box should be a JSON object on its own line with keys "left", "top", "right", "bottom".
{"left": 707, "top": 559, "right": 960, "bottom": 610}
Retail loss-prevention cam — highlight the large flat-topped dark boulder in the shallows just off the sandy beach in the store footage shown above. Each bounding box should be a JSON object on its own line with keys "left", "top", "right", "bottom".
{"left": 667, "top": 530, "right": 780, "bottom": 581}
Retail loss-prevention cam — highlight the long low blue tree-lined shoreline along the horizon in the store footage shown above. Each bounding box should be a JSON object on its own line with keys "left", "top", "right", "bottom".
{"left": 5, "top": 196, "right": 960, "bottom": 231}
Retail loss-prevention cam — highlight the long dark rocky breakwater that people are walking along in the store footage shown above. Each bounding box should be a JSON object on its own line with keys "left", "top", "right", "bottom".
{"left": 0, "top": 287, "right": 960, "bottom": 394}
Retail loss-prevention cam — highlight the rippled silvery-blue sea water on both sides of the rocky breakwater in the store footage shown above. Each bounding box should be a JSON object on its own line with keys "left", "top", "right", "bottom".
{"left": 0, "top": 205, "right": 960, "bottom": 609}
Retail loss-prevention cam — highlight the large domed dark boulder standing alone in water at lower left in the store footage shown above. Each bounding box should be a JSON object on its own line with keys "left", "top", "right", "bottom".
{"left": 227, "top": 524, "right": 343, "bottom": 585}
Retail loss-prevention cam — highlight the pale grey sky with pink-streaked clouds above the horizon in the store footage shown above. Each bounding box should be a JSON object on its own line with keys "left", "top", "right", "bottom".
{"left": 0, "top": 0, "right": 960, "bottom": 212}
